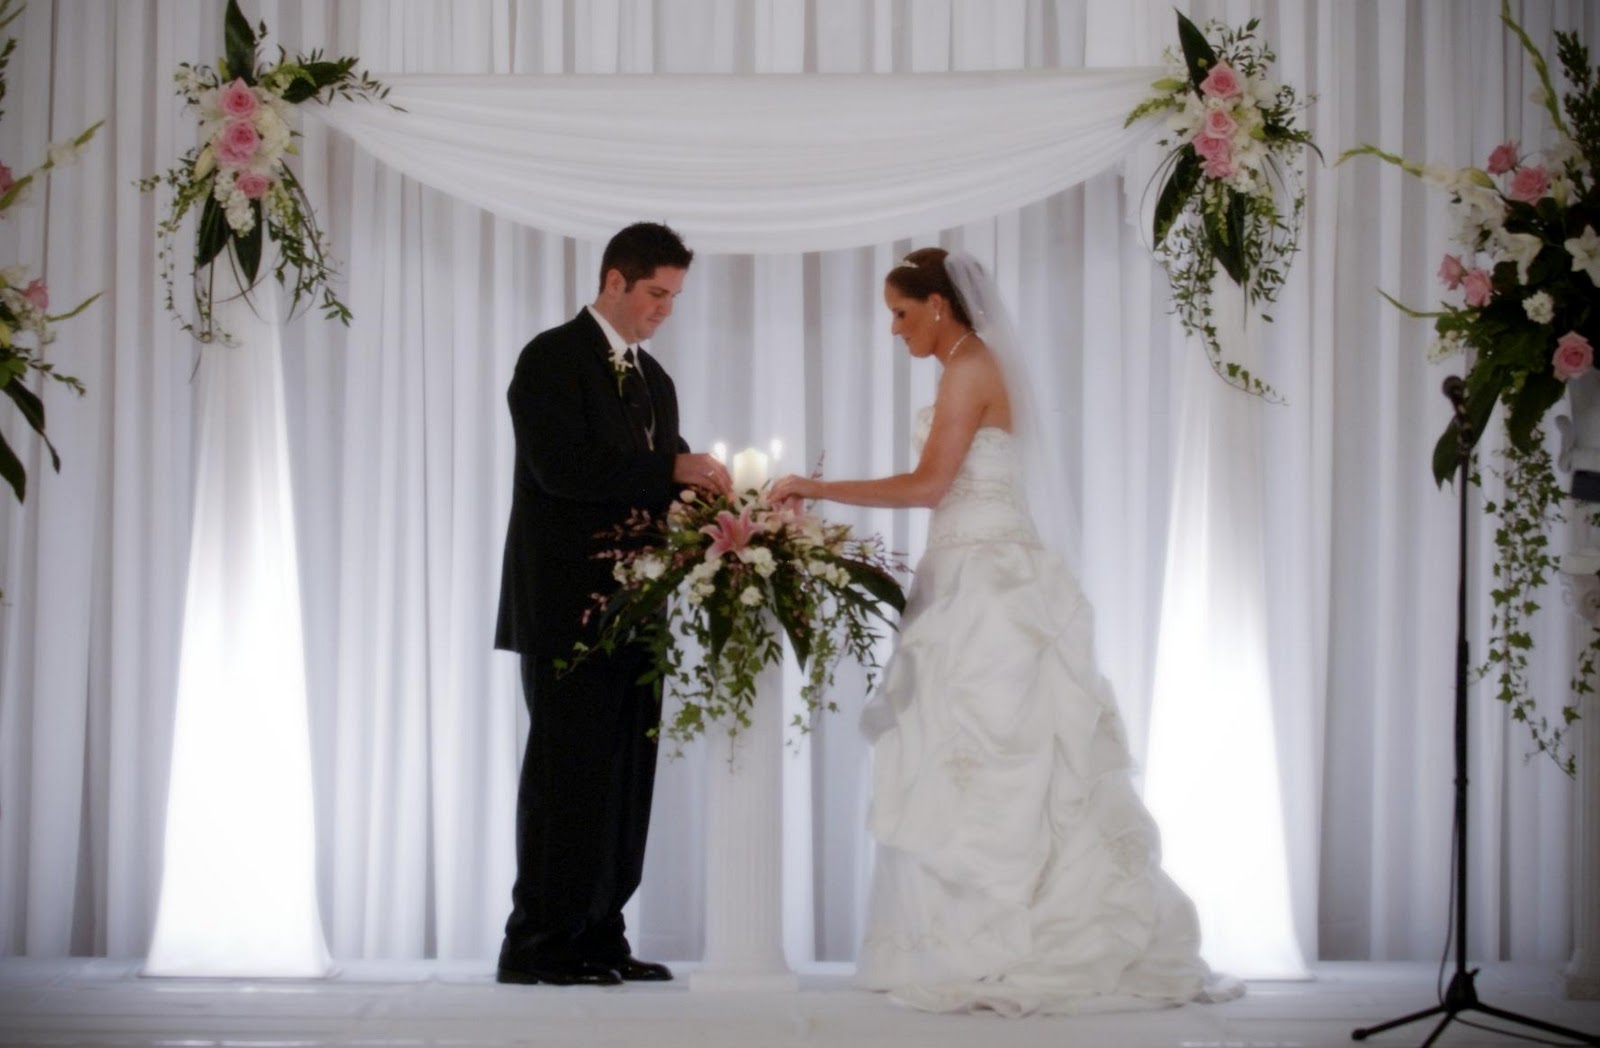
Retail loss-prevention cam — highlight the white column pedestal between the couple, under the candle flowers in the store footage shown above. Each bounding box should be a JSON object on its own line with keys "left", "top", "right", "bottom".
{"left": 690, "top": 666, "right": 800, "bottom": 992}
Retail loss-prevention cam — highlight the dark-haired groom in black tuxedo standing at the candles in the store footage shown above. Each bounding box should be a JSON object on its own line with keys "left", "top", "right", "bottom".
{"left": 494, "top": 222, "right": 731, "bottom": 986}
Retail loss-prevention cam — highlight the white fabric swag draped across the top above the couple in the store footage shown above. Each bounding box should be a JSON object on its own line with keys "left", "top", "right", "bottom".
{"left": 312, "top": 67, "right": 1158, "bottom": 253}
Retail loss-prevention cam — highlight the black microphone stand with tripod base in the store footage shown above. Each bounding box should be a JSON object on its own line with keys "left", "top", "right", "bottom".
{"left": 1350, "top": 376, "right": 1600, "bottom": 1048}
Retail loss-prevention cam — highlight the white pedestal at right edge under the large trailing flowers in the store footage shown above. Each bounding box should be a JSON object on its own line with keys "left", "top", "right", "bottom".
{"left": 1562, "top": 569, "right": 1600, "bottom": 1000}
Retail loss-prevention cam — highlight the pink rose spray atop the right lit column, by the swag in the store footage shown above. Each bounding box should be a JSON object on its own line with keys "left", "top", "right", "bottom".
{"left": 1125, "top": 13, "right": 1320, "bottom": 397}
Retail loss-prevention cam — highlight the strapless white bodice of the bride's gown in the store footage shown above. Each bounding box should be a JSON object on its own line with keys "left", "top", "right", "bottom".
{"left": 912, "top": 408, "right": 1038, "bottom": 549}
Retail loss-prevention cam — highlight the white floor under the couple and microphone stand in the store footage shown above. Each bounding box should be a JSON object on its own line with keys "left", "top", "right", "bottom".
{"left": 0, "top": 958, "right": 1600, "bottom": 1048}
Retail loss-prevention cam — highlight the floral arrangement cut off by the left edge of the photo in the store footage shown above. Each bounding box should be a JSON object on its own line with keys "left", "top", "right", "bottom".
{"left": 0, "top": 0, "right": 104, "bottom": 502}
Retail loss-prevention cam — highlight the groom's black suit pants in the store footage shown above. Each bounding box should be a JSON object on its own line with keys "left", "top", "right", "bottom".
{"left": 501, "top": 648, "right": 661, "bottom": 966}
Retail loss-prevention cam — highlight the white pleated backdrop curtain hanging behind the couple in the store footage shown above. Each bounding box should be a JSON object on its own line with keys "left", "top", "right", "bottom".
{"left": 0, "top": 0, "right": 1600, "bottom": 962}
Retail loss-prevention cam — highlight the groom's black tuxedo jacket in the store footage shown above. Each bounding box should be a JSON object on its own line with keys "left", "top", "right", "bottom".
{"left": 494, "top": 309, "right": 688, "bottom": 656}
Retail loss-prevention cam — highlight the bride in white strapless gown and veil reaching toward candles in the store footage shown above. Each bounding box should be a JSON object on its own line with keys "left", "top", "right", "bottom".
{"left": 771, "top": 248, "right": 1243, "bottom": 1014}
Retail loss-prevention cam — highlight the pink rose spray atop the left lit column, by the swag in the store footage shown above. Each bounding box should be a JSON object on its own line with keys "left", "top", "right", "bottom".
{"left": 139, "top": 0, "right": 389, "bottom": 342}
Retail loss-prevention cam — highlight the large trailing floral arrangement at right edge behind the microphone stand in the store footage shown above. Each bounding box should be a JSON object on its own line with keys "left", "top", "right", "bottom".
{"left": 1341, "top": 3, "right": 1600, "bottom": 773}
